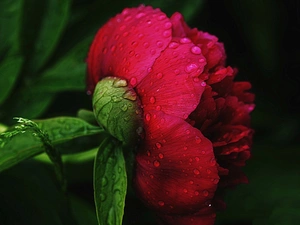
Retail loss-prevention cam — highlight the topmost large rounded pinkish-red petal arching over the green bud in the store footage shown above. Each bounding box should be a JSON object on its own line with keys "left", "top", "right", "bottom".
{"left": 87, "top": 5, "right": 172, "bottom": 92}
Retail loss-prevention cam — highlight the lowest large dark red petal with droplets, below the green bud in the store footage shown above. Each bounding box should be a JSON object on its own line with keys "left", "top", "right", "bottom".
{"left": 135, "top": 111, "right": 219, "bottom": 214}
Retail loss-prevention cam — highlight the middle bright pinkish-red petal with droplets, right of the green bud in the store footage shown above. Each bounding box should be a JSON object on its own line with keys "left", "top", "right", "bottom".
{"left": 137, "top": 38, "right": 206, "bottom": 119}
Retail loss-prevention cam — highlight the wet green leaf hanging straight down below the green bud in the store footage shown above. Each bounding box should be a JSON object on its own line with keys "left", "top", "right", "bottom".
{"left": 94, "top": 138, "right": 127, "bottom": 225}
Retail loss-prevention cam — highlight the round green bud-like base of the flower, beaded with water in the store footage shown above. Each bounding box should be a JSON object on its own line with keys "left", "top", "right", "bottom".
{"left": 93, "top": 77, "right": 143, "bottom": 145}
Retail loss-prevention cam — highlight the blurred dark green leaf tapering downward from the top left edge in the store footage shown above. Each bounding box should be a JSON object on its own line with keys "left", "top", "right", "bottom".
{"left": 22, "top": 0, "right": 71, "bottom": 73}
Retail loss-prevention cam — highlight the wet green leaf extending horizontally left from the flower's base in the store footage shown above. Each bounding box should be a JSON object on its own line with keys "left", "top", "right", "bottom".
{"left": 0, "top": 117, "right": 103, "bottom": 171}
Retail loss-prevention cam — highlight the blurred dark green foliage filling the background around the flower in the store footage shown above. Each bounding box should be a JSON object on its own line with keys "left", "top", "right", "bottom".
{"left": 0, "top": 0, "right": 300, "bottom": 225}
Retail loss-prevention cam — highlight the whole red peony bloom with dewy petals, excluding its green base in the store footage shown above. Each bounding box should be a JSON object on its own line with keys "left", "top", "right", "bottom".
{"left": 87, "top": 5, "right": 254, "bottom": 225}
